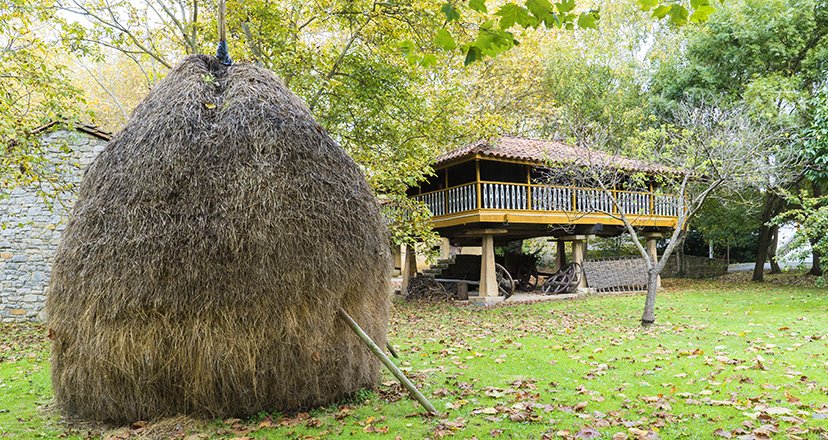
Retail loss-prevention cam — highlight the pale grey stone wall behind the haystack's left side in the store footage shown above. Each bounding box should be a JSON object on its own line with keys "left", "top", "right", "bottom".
{"left": 0, "top": 130, "right": 106, "bottom": 321}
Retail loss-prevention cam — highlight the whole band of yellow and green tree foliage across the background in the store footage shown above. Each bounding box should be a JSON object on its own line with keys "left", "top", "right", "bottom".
{"left": 0, "top": 0, "right": 828, "bottom": 262}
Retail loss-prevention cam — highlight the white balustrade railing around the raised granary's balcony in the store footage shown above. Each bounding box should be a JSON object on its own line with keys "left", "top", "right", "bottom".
{"left": 414, "top": 182, "right": 679, "bottom": 217}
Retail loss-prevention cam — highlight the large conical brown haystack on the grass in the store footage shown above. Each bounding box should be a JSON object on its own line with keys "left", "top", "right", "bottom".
{"left": 47, "top": 56, "right": 388, "bottom": 422}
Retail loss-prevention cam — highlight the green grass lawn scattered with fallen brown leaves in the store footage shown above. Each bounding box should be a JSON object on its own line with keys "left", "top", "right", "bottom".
{"left": 0, "top": 281, "right": 828, "bottom": 439}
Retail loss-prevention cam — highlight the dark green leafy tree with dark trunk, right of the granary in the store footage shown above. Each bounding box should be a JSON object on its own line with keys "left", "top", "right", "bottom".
{"left": 650, "top": 0, "right": 828, "bottom": 280}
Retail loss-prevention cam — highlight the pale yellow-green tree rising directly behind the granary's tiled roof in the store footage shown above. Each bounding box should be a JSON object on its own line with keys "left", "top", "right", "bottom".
{"left": 544, "top": 1, "right": 676, "bottom": 150}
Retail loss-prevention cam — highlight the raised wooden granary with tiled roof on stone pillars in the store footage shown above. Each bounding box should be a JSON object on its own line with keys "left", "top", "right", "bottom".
{"left": 408, "top": 136, "right": 680, "bottom": 304}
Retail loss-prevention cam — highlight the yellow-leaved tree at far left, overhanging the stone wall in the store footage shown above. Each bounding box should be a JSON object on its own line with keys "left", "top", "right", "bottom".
{"left": 0, "top": 0, "right": 83, "bottom": 201}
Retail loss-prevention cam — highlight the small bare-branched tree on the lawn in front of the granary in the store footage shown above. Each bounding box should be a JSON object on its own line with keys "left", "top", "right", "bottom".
{"left": 551, "top": 103, "right": 787, "bottom": 325}
